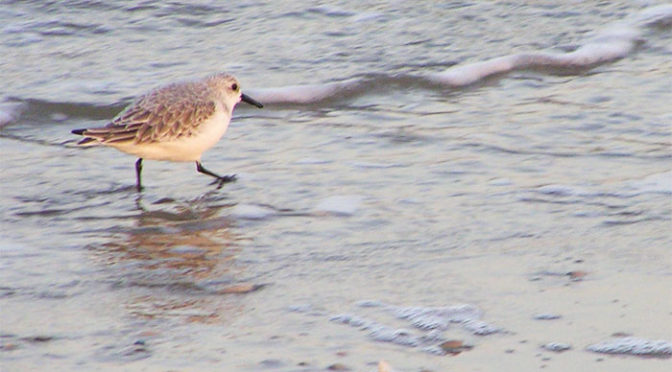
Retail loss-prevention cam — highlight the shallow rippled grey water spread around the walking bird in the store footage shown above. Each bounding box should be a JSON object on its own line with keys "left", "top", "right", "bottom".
{"left": 0, "top": 1, "right": 672, "bottom": 371}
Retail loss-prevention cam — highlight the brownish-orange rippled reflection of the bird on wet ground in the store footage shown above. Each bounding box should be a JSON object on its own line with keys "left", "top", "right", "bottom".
{"left": 96, "top": 200, "right": 262, "bottom": 322}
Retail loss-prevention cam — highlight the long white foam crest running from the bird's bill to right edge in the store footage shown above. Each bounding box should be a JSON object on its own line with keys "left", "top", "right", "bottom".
{"left": 248, "top": 4, "right": 672, "bottom": 104}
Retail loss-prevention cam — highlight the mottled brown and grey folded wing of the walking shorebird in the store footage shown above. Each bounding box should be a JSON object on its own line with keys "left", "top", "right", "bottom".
{"left": 82, "top": 84, "right": 217, "bottom": 145}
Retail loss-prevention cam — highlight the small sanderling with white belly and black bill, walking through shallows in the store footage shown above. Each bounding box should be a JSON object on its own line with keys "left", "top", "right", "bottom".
{"left": 72, "top": 74, "right": 263, "bottom": 191}
